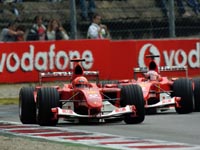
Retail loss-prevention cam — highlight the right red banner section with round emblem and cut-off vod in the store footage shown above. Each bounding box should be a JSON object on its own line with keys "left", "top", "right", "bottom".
{"left": 136, "top": 39, "right": 200, "bottom": 77}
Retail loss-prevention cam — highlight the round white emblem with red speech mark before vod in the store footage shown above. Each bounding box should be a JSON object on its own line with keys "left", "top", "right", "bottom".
{"left": 138, "top": 43, "right": 160, "bottom": 67}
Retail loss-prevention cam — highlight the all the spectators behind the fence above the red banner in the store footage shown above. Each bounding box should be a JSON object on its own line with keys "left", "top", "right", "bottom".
{"left": 0, "top": 0, "right": 200, "bottom": 42}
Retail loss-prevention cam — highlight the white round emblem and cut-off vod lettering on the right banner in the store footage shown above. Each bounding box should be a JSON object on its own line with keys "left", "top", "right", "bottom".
{"left": 138, "top": 42, "right": 200, "bottom": 68}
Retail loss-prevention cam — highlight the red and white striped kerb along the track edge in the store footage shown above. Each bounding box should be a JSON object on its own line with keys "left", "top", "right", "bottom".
{"left": 0, "top": 121, "right": 200, "bottom": 150}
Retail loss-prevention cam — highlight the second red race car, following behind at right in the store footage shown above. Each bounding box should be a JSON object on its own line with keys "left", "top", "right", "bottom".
{"left": 134, "top": 55, "right": 197, "bottom": 114}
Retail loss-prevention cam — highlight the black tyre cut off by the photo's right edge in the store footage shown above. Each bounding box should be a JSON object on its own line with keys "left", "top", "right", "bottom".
{"left": 193, "top": 78, "right": 200, "bottom": 112}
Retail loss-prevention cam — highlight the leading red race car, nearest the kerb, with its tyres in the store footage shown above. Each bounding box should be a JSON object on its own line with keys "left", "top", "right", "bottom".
{"left": 19, "top": 59, "right": 145, "bottom": 126}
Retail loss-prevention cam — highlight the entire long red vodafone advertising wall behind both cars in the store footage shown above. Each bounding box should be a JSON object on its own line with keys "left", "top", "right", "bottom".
{"left": 0, "top": 39, "right": 200, "bottom": 83}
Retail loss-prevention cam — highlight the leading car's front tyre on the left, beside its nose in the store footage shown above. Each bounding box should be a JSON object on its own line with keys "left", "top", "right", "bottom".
{"left": 37, "top": 87, "right": 59, "bottom": 126}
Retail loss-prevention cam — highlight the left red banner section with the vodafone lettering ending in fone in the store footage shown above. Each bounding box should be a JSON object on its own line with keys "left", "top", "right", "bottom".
{"left": 0, "top": 40, "right": 110, "bottom": 83}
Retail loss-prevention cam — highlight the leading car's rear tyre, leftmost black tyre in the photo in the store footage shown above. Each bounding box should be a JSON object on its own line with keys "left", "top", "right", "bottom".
{"left": 19, "top": 87, "right": 36, "bottom": 124}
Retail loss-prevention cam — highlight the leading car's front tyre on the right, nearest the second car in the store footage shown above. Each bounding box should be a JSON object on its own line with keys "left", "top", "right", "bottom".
{"left": 120, "top": 85, "right": 145, "bottom": 124}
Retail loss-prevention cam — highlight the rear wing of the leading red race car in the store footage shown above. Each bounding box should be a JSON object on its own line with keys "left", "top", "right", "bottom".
{"left": 39, "top": 71, "right": 99, "bottom": 85}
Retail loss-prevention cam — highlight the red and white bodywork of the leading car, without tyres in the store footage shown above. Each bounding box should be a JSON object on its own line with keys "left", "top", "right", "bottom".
{"left": 34, "top": 59, "right": 139, "bottom": 122}
